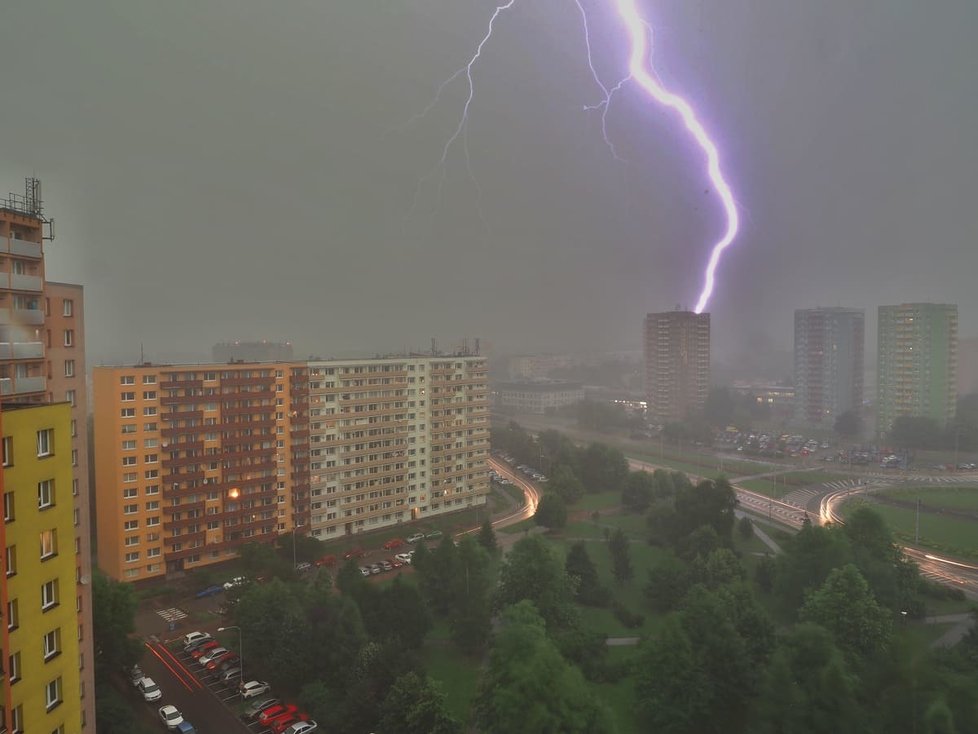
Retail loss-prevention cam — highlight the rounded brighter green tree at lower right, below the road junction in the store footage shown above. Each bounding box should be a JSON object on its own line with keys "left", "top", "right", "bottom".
{"left": 799, "top": 563, "right": 892, "bottom": 659}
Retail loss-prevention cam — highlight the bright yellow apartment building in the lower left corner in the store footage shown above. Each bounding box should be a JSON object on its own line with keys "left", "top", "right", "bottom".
{"left": 0, "top": 402, "right": 83, "bottom": 734}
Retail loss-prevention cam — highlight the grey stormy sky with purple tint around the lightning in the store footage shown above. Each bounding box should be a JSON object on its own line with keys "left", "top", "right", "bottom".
{"left": 0, "top": 0, "right": 978, "bottom": 364}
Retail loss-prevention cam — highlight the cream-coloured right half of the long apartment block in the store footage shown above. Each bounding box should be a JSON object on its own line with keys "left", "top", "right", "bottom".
{"left": 300, "top": 355, "right": 489, "bottom": 540}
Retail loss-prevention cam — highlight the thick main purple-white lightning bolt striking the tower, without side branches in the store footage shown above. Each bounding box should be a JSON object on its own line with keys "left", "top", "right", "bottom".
{"left": 616, "top": 0, "right": 740, "bottom": 313}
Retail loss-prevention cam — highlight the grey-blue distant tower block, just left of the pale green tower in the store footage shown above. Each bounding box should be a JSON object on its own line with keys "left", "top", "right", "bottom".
{"left": 795, "top": 308, "right": 866, "bottom": 428}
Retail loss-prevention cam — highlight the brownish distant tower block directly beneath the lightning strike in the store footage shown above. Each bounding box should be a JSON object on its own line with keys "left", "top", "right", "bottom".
{"left": 644, "top": 311, "right": 710, "bottom": 421}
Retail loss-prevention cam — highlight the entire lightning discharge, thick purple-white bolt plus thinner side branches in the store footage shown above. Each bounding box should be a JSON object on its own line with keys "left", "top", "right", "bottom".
{"left": 407, "top": 0, "right": 740, "bottom": 313}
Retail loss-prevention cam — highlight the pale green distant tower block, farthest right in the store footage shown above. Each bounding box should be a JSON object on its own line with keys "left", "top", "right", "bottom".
{"left": 876, "top": 303, "right": 958, "bottom": 434}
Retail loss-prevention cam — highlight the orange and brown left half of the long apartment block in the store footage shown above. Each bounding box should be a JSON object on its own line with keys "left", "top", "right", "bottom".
{"left": 93, "top": 364, "right": 293, "bottom": 581}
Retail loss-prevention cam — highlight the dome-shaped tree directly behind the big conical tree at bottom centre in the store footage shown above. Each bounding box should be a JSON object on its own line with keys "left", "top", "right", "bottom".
{"left": 496, "top": 535, "right": 576, "bottom": 628}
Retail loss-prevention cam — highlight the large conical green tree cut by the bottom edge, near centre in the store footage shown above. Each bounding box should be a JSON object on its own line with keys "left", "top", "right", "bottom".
{"left": 476, "top": 601, "right": 612, "bottom": 734}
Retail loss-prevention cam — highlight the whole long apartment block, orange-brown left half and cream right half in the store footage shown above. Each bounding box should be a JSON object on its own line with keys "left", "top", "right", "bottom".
{"left": 93, "top": 356, "right": 489, "bottom": 581}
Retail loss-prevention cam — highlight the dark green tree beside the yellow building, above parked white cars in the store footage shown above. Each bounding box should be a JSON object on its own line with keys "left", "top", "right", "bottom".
{"left": 92, "top": 569, "right": 143, "bottom": 678}
